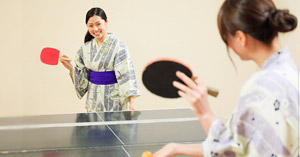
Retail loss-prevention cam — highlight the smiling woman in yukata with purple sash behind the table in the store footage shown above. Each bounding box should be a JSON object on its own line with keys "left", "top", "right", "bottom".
{"left": 60, "top": 8, "right": 140, "bottom": 112}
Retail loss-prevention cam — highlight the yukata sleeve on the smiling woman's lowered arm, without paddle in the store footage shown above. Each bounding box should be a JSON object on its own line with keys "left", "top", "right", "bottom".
{"left": 114, "top": 43, "right": 140, "bottom": 104}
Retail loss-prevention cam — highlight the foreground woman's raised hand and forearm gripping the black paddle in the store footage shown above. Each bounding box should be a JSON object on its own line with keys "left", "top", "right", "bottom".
{"left": 173, "top": 71, "right": 216, "bottom": 133}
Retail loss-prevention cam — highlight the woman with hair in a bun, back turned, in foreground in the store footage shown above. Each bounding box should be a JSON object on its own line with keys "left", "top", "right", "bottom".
{"left": 154, "top": 0, "right": 300, "bottom": 157}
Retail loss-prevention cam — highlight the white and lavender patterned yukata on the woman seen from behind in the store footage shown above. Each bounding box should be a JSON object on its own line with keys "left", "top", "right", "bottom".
{"left": 202, "top": 48, "right": 300, "bottom": 157}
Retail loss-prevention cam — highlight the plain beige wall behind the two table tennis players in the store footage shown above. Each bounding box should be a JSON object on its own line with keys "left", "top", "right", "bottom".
{"left": 0, "top": 0, "right": 300, "bottom": 117}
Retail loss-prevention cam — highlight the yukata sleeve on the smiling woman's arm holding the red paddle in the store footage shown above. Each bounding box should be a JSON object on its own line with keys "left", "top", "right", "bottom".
{"left": 70, "top": 47, "right": 89, "bottom": 99}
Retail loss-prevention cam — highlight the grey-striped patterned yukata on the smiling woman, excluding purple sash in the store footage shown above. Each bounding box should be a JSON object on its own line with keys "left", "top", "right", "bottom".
{"left": 70, "top": 33, "right": 140, "bottom": 112}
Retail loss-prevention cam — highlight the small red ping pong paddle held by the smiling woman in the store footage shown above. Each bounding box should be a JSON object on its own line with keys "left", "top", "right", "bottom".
{"left": 40, "top": 47, "right": 71, "bottom": 65}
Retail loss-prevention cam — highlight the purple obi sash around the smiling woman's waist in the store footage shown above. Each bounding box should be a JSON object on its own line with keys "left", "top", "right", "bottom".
{"left": 89, "top": 70, "right": 118, "bottom": 85}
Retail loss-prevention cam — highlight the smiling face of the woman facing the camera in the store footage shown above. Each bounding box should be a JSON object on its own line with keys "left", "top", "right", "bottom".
{"left": 87, "top": 15, "right": 108, "bottom": 41}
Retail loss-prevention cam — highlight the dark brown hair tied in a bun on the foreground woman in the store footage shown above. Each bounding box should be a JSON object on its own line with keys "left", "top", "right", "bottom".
{"left": 217, "top": 0, "right": 297, "bottom": 45}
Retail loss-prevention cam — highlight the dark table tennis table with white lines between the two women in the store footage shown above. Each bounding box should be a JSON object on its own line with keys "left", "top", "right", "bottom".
{"left": 0, "top": 108, "right": 206, "bottom": 157}
